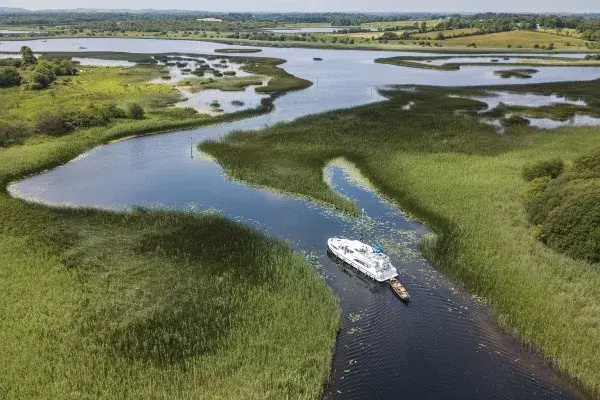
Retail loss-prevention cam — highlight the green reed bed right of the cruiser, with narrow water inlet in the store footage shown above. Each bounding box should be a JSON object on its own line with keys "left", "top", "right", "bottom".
{"left": 202, "top": 81, "right": 600, "bottom": 395}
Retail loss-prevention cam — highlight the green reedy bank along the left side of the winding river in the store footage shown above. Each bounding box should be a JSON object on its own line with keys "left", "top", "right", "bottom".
{"left": 0, "top": 57, "right": 339, "bottom": 399}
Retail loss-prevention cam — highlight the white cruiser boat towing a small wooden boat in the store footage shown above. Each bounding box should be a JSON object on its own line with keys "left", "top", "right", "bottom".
{"left": 327, "top": 238, "right": 398, "bottom": 282}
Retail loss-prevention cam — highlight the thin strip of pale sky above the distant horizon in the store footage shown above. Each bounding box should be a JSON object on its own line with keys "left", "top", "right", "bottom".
{"left": 0, "top": 0, "right": 600, "bottom": 13}
